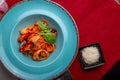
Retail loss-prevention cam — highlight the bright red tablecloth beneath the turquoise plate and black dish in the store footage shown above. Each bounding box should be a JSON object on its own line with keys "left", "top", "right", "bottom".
{"left": 2, "top": 0, "right": 120, "bottom": 80}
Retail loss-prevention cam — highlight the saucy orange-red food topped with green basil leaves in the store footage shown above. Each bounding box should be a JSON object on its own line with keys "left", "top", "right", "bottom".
{"left": 18, "top": 19, "right": 57, "bottom": 60}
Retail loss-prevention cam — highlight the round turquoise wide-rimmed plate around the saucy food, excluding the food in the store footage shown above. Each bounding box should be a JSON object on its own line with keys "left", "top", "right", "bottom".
{"left": 0, "top": 0, "right": 79, "bottom": 80}
